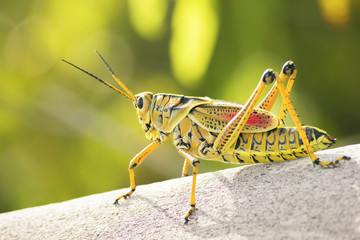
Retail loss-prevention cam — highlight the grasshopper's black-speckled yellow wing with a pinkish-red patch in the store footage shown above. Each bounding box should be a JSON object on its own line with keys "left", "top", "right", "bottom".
{"left": 188, "top": 100, "right": 280, "bottom": 133}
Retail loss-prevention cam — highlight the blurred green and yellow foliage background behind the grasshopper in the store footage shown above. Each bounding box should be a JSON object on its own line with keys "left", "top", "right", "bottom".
{"left": 0, "top": 0, "right": 360, "bottom": 212}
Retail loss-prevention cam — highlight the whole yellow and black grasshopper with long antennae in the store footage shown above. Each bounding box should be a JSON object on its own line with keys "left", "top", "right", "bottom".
{"left": 63, "top": 52, "right": 350, "bottom": 223}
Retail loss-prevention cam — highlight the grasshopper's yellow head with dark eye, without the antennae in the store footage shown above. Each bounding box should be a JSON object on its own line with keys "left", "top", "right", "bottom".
{"left": 134, "top": 92, "right": 153, "bottom": 132}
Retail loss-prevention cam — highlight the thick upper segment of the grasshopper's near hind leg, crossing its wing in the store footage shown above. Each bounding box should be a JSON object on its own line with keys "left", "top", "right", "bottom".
{"left": 214, "top": 69, "right": 275, "bottom": 152}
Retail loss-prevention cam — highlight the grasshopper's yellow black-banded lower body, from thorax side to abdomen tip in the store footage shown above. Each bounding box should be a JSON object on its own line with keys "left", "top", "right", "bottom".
{"left": 172, "top": 118, "right": 335, "bottom": 163}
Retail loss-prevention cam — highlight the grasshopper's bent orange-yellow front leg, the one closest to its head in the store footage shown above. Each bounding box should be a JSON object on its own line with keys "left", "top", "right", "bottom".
{"left": 114, "top": 141, "right": 161, "bottom": 204}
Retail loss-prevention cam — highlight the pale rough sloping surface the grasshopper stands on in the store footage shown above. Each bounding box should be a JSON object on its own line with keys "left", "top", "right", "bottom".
{"left": 0, "top": 145, "right": 360, "bottom": 239}
